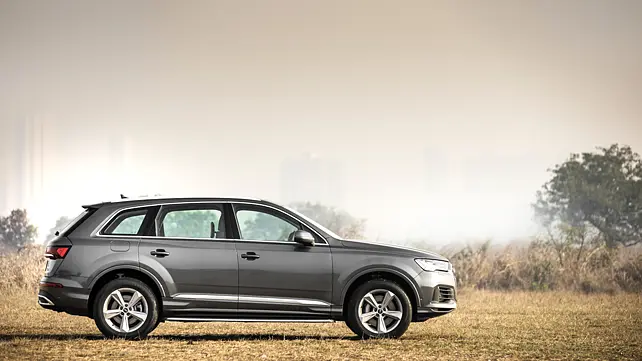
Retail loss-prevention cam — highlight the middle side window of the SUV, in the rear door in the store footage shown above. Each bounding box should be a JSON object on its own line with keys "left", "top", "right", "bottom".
{"left": 157, "top": 205, "right": 225, "bottom": 239}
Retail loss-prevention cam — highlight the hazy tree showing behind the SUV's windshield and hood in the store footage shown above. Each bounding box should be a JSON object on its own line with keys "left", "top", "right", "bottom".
{"left": 291, "top": 202, "right": 366, "bottom": 239}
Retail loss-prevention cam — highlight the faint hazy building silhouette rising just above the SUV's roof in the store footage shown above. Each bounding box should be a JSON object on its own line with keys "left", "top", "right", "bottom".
{"left": 280, "top": 153, "right": 344, "bottom": 207}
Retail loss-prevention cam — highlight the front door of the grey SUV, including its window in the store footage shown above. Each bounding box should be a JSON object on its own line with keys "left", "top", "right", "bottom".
{"left": 234, "top": 204, "right": 332, "bottom": 319}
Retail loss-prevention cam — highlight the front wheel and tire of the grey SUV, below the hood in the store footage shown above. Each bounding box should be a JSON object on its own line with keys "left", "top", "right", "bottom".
{"left": 346, "top": 279, "right": 412, "bottom": 339}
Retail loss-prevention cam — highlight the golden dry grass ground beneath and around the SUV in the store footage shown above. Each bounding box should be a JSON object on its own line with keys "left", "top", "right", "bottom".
{"left": 0, "top": 291, "right": 642, "bottom": 361}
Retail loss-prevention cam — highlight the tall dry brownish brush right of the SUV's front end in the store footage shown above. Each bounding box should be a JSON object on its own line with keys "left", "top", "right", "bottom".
{"left": 445, "top": 226, "right": 642, "bottom": 293}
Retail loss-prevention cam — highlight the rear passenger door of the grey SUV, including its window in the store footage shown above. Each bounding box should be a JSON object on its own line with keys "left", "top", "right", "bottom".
{"left": 139, "top": 203, "right": 238, "bottom": 317}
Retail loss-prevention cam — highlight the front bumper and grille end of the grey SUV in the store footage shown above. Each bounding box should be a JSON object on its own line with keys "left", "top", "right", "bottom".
{"left": 413, "top": 271, "right": 457, "bottom": 322}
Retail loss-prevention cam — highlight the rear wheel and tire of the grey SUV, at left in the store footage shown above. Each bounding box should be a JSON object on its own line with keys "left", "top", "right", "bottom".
{"left": 93, "top": 277, "right": 159, "bottom": 339}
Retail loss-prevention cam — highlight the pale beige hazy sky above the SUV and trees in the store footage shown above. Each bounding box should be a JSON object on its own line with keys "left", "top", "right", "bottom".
{"left": 0, "top": 0, "right": 642, "bottom": 241}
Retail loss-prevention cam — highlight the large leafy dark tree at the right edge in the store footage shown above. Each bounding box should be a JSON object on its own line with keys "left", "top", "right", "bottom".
{"left": 533, "top": 144, "right": 642, "bottom": 247}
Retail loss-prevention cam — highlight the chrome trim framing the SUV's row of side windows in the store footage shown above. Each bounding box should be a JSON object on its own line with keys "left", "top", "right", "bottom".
{"left": 90, "top": 201, "right": 330, "bottom": 246}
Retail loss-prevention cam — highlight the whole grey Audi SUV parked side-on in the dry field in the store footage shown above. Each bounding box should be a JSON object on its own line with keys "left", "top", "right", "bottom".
{"left": 38, "top": 198, "right": 456, "bottom": 338}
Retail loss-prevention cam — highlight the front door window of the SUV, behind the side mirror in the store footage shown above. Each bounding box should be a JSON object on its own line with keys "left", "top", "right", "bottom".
{"left": 236, "top": 209, "right": 299, "bottom": 241}
